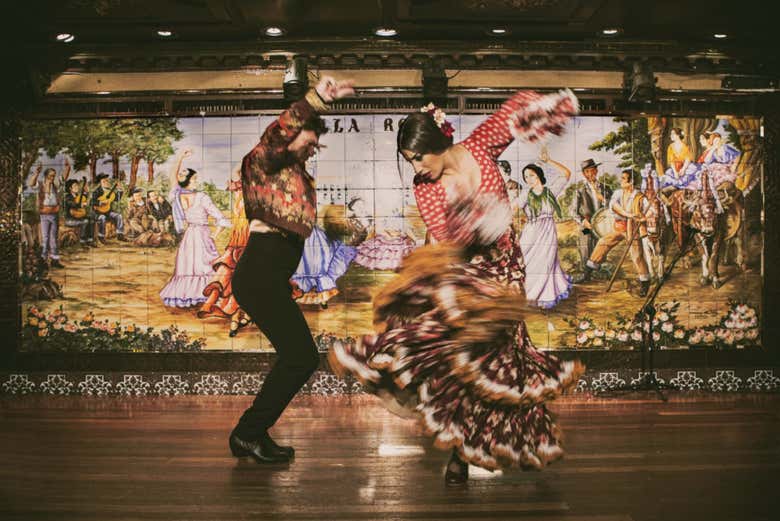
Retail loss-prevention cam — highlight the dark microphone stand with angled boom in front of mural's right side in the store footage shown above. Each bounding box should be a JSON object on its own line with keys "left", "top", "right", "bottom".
{"left": 623, "top": 225, "right": 696, "bottom": 402}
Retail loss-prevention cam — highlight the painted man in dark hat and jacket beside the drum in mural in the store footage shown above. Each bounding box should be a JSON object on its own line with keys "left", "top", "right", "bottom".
{"left": 572, "top": 159, "right": 612, "bottom": 273}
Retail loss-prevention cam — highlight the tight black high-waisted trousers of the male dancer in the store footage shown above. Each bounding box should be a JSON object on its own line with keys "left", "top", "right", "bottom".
{"left": 232, "top": 233, "right": 320, "bottom": 441}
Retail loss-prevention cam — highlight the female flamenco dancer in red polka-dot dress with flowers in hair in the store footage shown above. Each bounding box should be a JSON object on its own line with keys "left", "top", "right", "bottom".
{"left": 329, "top": 91, "right": 583, "bottom": 483}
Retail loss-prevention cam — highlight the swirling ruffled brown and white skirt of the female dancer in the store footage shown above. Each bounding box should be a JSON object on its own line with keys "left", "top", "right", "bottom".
{"left": 328, "top": 243, "right": 584, "bottom": 469}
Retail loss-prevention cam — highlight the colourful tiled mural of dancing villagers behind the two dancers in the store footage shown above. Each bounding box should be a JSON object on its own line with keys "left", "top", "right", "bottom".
{"left": 21, "top": 114, "right": 763, "bottom": 351}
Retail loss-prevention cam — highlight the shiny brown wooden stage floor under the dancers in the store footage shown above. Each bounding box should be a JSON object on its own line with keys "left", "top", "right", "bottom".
{"left": 0, "top": 394, "right": 780, "bottom": 521}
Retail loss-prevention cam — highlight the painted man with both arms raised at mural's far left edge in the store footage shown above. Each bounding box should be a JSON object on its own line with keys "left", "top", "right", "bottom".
{"left": 28, "top": 159, "right": 70, "bottom": 268}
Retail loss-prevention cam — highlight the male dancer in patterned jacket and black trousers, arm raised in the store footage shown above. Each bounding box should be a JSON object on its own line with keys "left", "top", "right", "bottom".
{"left": 229, "top": 76, "right": 354, "bottom": 463}
